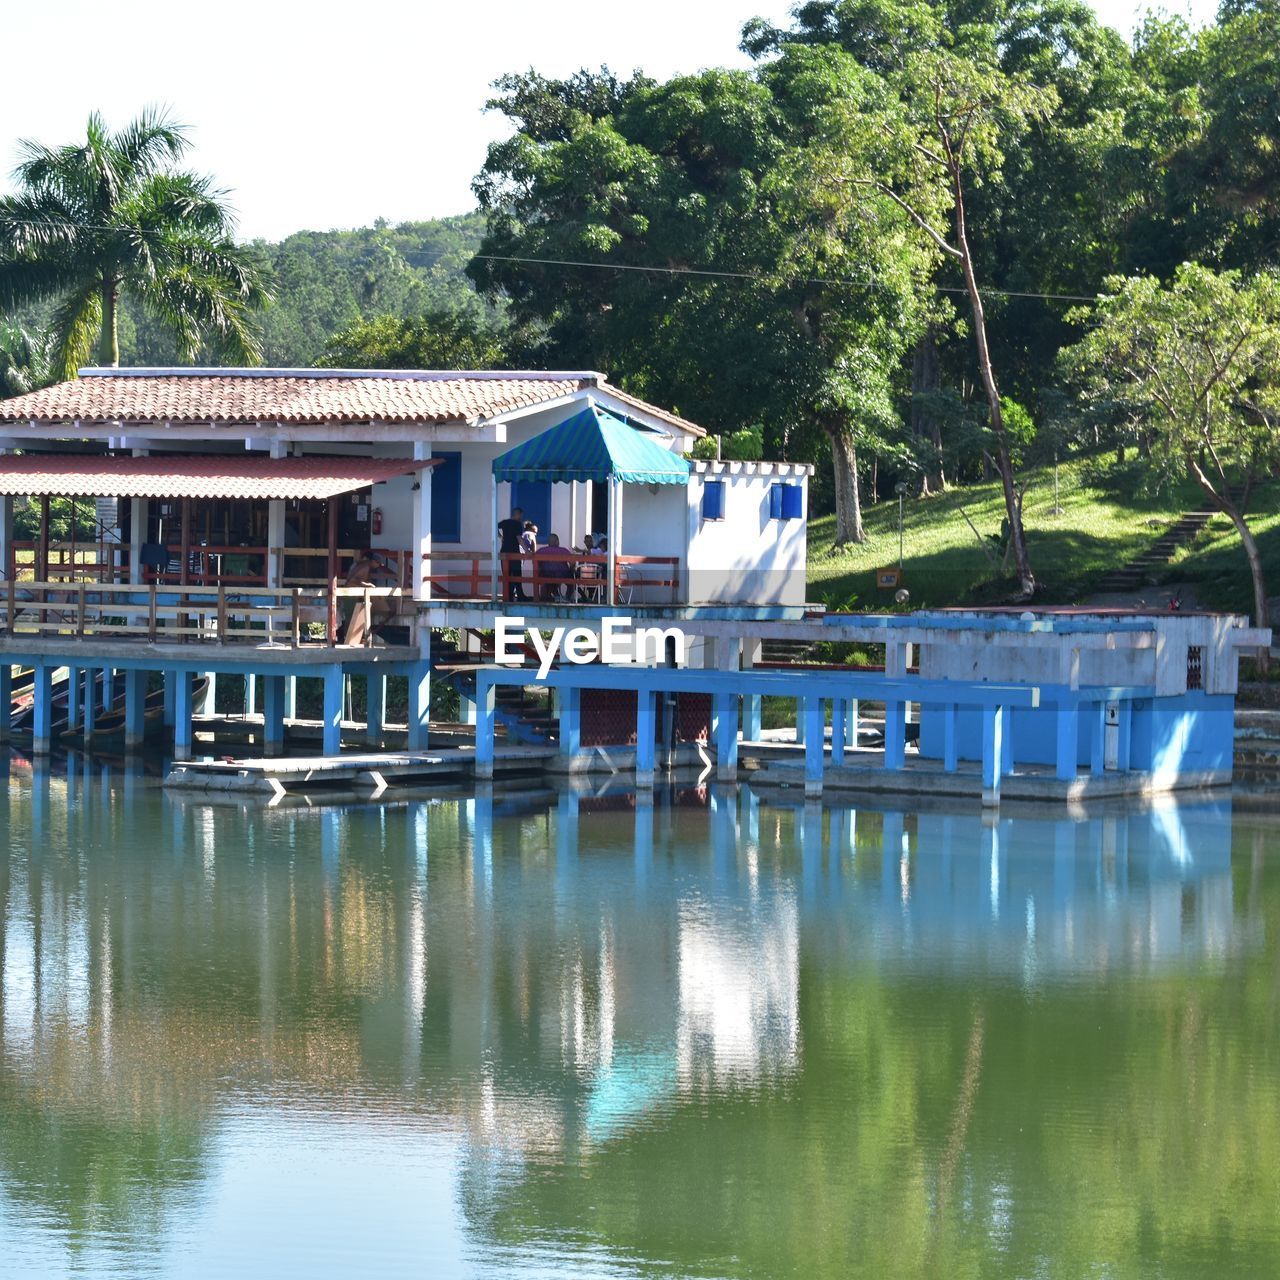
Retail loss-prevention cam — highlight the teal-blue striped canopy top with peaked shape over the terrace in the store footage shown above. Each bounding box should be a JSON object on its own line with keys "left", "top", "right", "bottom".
{"left": 493, "top": 404, "right": 689, "bottom": 484}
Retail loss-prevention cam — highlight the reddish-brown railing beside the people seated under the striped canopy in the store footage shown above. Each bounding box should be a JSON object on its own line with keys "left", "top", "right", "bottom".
{"left": 422, "top": 547, "right": 680, "bottom": 604}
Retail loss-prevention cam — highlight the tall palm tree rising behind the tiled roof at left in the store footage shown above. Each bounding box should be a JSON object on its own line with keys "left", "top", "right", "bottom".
{"left": 0, "top": 109, "right": 268, "bottom": 378}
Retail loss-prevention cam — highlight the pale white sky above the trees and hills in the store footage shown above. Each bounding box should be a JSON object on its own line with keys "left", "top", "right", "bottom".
{"left": 0, "top": 0, "right": 1216, "bottom": 239}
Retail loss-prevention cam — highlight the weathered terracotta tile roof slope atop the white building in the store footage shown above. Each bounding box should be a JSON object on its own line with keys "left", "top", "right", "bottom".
{"left": 0, "top": 370, "right": 598, "bottom": 424}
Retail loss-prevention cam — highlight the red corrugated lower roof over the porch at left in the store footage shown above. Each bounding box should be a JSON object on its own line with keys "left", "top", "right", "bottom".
{"left": 0, "top": 453, "right": 434, "bottom": 499}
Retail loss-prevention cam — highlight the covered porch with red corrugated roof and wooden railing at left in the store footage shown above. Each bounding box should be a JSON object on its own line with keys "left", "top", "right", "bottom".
{"left": 0, "top": 453, "right": 433, "bottom": 646}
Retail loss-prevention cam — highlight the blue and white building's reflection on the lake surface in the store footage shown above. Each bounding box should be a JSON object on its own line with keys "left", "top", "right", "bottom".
{"left": 0, "top": 764, "right": 1258, "bottom": 1274}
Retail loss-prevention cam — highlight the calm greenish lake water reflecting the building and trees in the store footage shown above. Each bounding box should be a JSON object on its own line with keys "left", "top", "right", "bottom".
{"left": 0, "top": 760, "right": 1280, "bottom": 1280}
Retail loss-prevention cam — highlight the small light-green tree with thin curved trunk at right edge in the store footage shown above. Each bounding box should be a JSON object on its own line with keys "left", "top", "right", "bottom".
{"left": 1062, "top": 264, "right": 1280, "bottom": 626}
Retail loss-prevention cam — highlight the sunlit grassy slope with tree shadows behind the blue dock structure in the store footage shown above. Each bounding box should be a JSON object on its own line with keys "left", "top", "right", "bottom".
{"left": 809, "top": 460, "right": 1280, "bottom": 613}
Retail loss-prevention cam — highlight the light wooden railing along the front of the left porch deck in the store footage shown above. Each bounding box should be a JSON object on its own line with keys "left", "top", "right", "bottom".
{"left": 0, "top": 579, "right": 411, "bottom": 645}
